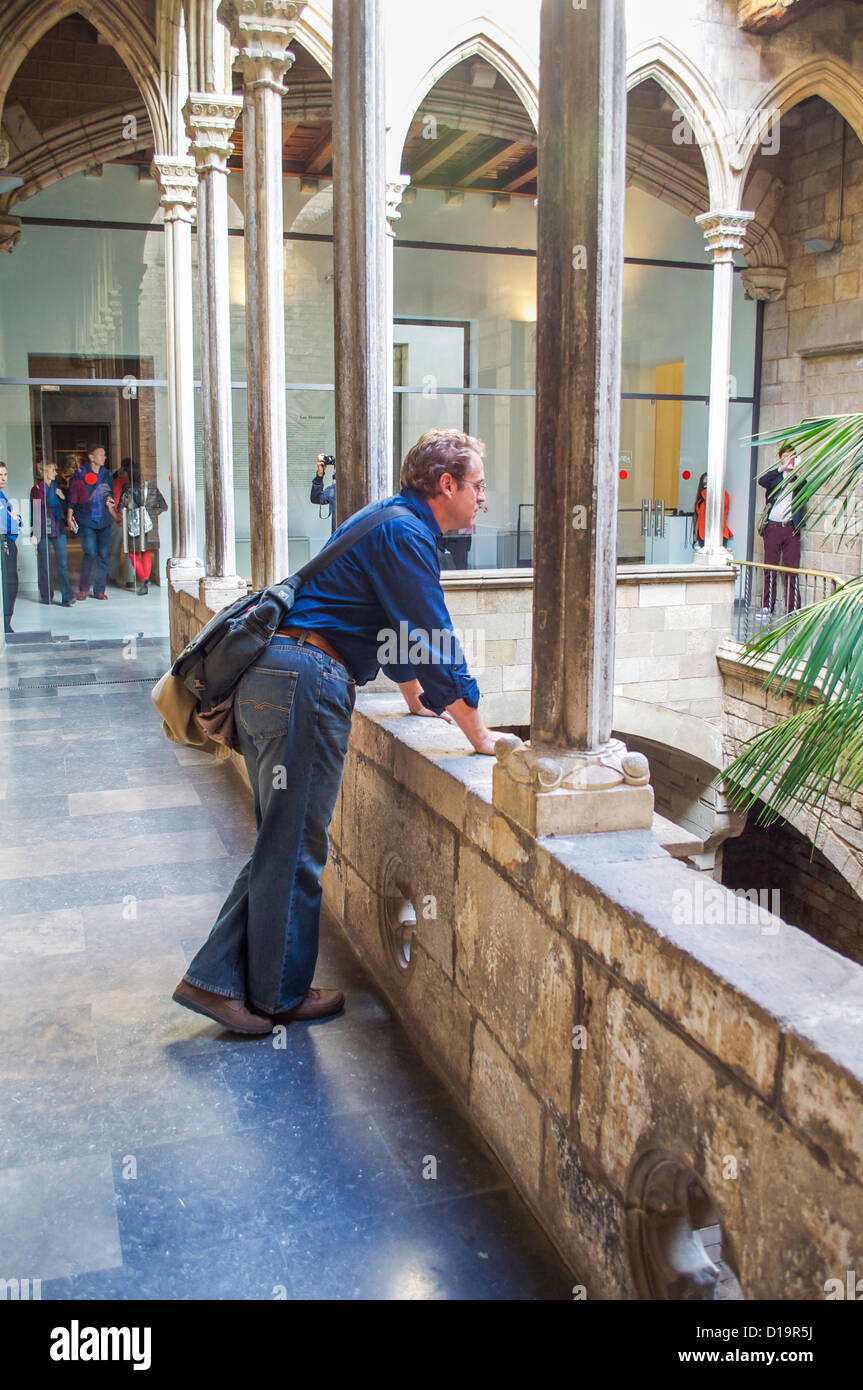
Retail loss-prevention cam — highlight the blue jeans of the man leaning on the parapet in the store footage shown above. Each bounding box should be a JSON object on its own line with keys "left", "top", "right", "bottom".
{"left": 185, "top": 637, "right": 356, "bottom": 1013}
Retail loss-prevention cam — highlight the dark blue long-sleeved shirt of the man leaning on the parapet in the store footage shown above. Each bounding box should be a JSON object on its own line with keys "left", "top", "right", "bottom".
{"left": 286, "top": 488, "right": 479, "bottom": 714}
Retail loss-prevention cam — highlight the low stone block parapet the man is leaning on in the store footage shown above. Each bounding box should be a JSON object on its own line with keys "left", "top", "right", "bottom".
{"left": 324, "top": 695, "right": 863, "bottom": 1300}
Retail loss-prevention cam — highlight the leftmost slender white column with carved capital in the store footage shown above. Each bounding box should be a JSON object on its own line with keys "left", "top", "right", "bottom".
{"left": 153, "top": 154, "right": 204, "bottom": 594}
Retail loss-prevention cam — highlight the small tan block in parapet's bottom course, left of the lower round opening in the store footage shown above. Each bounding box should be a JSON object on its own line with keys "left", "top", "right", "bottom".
{"left": 470, "top": 1022, "right": 542, "bottom": 1201}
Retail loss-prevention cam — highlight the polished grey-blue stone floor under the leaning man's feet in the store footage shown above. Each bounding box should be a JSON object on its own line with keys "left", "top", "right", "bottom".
{"left": 0, "top": 636, "right": 573, "bottom": 1300}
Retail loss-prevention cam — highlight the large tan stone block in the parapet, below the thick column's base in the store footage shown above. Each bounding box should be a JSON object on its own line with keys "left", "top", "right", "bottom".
{"left": 456, "top": 848, "right": 575, "bottom": 1111}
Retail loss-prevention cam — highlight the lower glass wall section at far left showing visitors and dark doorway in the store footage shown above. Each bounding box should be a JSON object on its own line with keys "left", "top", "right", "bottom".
{"left": 0, "top": 379, "right": 171, "bottom": 642}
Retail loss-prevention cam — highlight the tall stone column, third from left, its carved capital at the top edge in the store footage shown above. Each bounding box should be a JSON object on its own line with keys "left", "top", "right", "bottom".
{"left": 218, "top": 0, "right": 306, "bottom": 588}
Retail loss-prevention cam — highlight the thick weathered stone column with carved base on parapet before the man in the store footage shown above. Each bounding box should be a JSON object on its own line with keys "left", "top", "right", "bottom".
{"left": 493, "top": 0, "right": 653, "bottom": 835}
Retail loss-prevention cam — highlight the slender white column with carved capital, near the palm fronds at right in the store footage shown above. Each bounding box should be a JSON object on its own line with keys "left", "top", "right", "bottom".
{"left": 695, "top": 211, "right": 755, "bottom": 564}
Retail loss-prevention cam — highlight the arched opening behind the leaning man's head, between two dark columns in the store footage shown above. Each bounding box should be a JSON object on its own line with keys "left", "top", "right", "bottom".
{"left": 393, "top": 53, "right": 536, "bottom": 570}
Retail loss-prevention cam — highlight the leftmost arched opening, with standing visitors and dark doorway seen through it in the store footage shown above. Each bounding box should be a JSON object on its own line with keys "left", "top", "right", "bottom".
{"left": 0, "top": 14, "right": 171, "bottom": 638}
